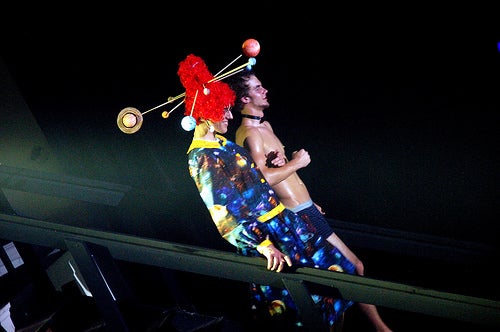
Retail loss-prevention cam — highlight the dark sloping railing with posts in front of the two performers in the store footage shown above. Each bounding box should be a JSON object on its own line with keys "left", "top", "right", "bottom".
{"left": 0, "top": 214, "right": 500, "bottom": 331}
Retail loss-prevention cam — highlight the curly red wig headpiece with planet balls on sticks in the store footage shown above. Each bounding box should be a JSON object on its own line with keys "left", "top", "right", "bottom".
{"left": 116, "top": 39, "right": 260, "bottom": 134}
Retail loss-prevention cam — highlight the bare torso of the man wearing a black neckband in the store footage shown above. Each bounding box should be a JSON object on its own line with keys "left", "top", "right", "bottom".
{"left": 236, "top": 122, "right": 311, "bottom": 208}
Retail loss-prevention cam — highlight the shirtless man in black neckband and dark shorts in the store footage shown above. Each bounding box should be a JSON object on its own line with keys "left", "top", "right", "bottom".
{"left": 228, "top": 71, "right": 391, "bottom": 331}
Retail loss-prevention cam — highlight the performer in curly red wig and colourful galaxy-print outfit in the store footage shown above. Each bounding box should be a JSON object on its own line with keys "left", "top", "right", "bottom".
{"left": 178, "top": 54, "right": 355, "bottom": 327}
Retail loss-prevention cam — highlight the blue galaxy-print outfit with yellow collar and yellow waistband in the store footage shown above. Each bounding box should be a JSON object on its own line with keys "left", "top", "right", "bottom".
{"left": 188, "top": 135, "right": 354, "bottom": 325}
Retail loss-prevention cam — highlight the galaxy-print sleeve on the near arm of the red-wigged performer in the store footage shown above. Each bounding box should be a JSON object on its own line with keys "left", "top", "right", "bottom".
{"left": 189, "top": 149, "right": 269, "bottom": 250}
